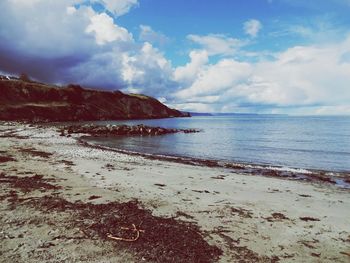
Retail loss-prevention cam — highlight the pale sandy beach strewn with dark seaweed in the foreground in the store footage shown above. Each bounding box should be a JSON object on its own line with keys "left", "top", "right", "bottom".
{"left": 0, "top": 122, "right": 350, "bottom": 262}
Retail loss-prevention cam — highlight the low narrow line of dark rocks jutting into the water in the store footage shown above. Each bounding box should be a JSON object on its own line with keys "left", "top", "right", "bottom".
{"left": 59, "top": 124, "right": 200, "bottom": 137}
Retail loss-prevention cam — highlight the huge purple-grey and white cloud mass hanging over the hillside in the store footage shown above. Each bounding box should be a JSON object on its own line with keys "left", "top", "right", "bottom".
{"left": 0, "top": 0, "right": 171, "bottom": 95}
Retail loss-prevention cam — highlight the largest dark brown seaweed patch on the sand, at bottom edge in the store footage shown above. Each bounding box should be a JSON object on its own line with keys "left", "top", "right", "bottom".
{"left": 26, "top": 196, "right": 222, "bottom": 262}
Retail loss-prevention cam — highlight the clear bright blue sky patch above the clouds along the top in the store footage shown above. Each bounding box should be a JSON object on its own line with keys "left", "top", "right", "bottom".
{"left": 116, "top": 0, "right": 350, "bottom": 66}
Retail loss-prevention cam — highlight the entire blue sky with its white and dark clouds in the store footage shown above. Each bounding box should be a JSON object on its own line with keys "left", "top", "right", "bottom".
{"left": 0, "top": 0, "right": 350, "bottom": 115}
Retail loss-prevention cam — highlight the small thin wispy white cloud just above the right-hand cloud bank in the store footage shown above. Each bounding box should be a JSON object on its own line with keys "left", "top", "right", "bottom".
{"left": 187, "top": 34, "right": 245, "bottom": 55}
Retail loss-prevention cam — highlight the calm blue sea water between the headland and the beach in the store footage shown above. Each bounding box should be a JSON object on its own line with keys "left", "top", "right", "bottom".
{"left": 84, "top": 115, "right": 350, "bottom": 172}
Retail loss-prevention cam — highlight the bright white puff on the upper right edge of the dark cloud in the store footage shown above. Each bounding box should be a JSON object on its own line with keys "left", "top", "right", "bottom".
{"left": 85, "top": 13, "right": 132, "bottom": 45}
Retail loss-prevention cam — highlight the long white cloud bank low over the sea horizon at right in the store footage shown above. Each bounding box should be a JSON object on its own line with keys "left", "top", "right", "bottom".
{"left": 175, "top": 36, "right": 350, "bottom": 114}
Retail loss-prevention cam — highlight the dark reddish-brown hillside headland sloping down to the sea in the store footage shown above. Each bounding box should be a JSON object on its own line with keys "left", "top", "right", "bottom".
{"left": 0, "top": 76, "right": 189, "bottom": 121}
